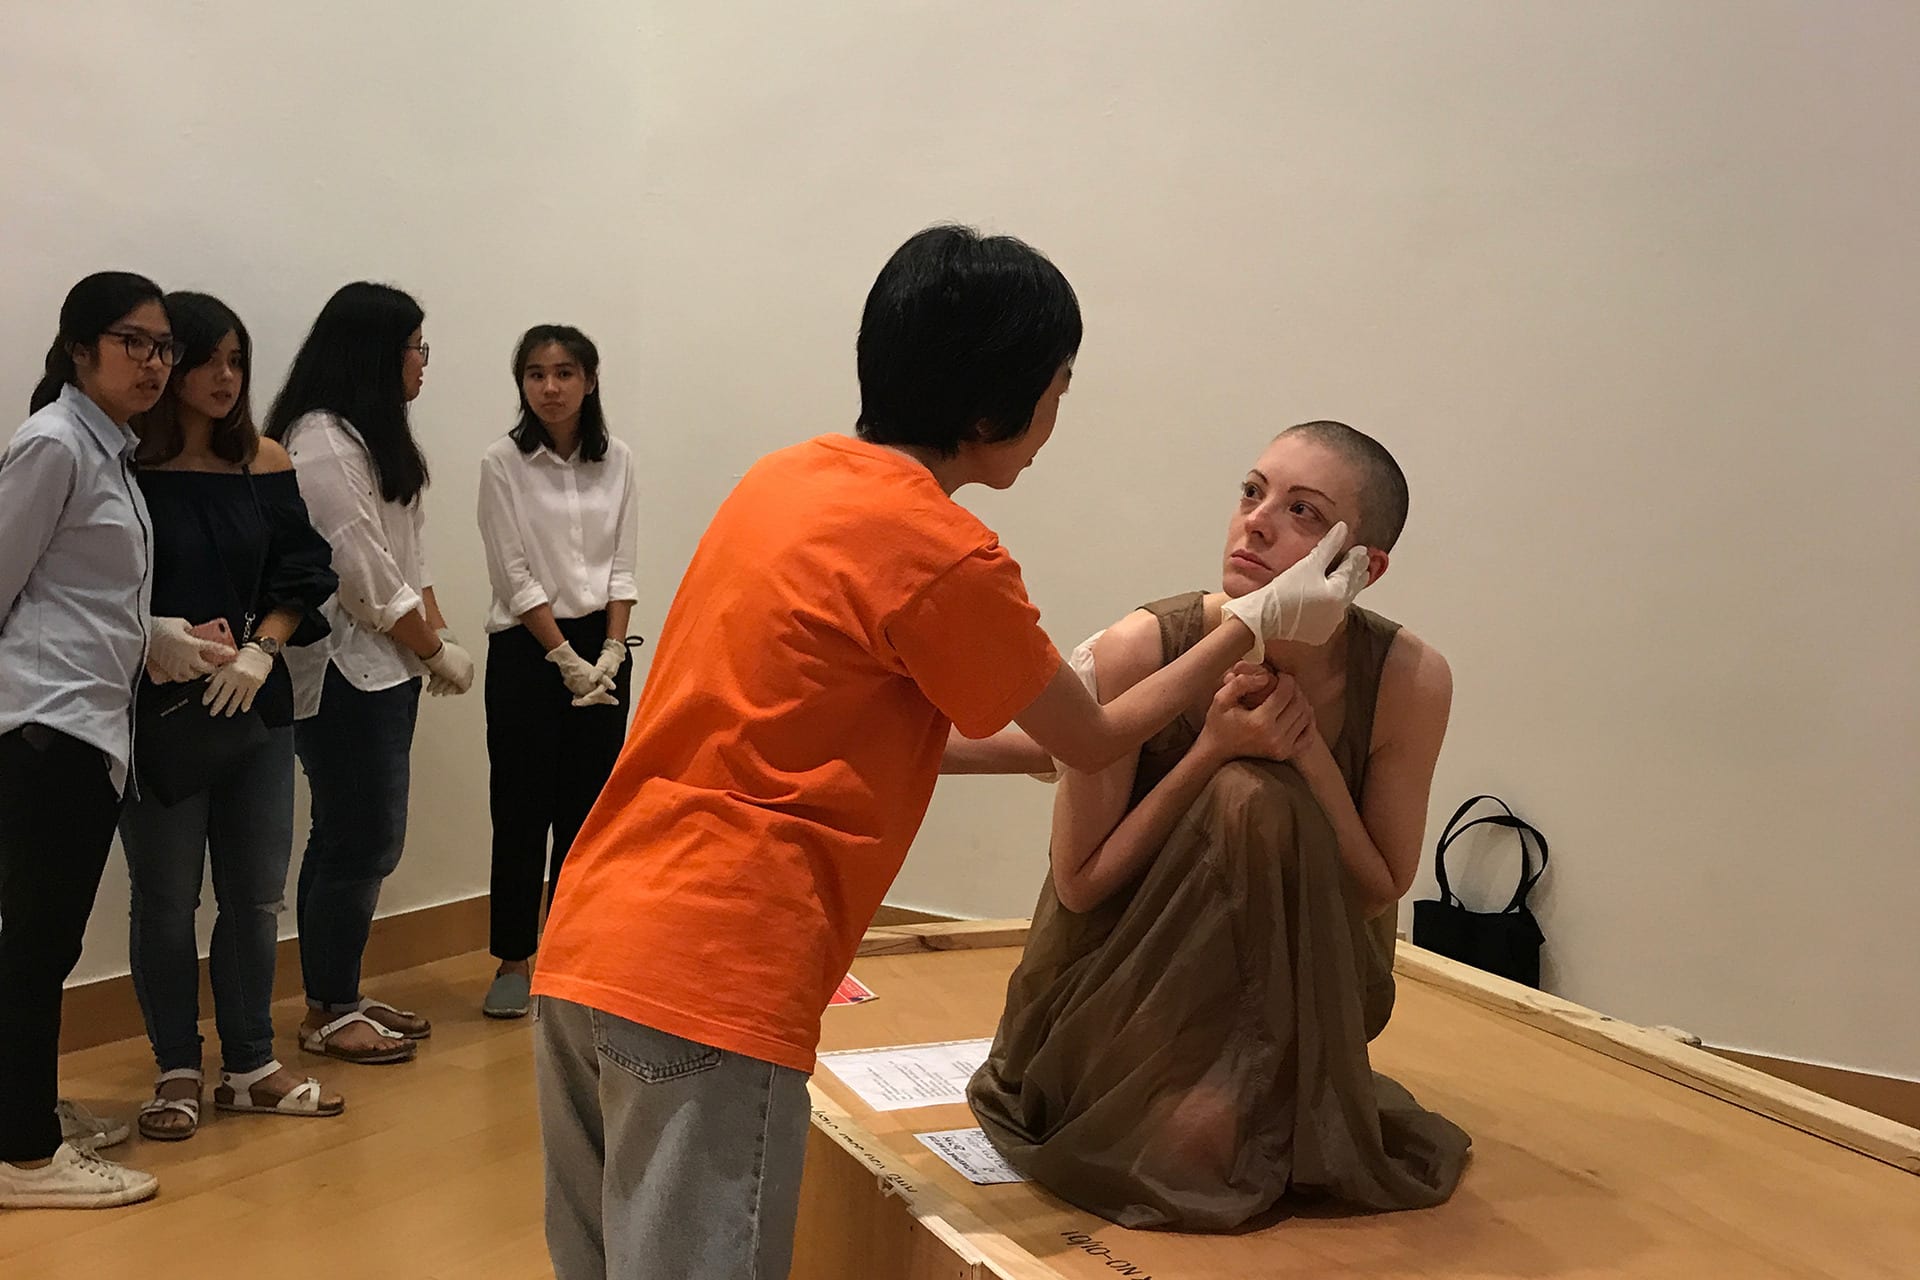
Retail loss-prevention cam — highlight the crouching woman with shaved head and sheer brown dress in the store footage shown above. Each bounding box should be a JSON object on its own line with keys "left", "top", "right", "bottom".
{"left": 954, "top": 422, "right": 1471, "bottom": 1230}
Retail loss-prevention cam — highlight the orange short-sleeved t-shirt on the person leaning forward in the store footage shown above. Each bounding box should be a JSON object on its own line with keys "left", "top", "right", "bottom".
{"left": 534, "top": 436, "right": 1060, "bottom": 1071}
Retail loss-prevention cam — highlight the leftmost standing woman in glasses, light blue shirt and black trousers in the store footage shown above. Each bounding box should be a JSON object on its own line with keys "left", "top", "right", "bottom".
{"left": 0, "top": 271, "right": 232, "bottom": 1209}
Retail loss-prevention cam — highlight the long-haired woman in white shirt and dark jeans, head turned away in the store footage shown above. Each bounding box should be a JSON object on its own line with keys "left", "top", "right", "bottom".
{"left": 267, "top": 282, "right": 474, "bottom": 1063}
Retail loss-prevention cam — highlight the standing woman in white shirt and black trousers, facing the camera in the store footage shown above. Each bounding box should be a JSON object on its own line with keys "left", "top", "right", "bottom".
{"left": 480, "top": 324, "right": 637, "bottom": 1017}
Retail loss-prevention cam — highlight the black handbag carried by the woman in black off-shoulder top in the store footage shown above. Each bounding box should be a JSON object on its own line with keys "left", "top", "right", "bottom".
{"left": 134, "top": 472, "right": 269, "bottom": 806}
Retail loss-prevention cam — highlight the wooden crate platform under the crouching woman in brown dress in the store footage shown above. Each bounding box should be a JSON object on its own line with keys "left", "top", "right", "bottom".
{"left": 795, "top": 923, "right": 1920, "bottom": 1280}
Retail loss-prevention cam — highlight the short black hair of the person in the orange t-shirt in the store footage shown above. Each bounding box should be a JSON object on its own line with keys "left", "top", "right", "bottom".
{"left": 858, "top": 226, "right": 1081, "bottom": 457}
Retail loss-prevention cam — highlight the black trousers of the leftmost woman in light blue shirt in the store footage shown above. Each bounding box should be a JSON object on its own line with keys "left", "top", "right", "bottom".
{"left": 0, "top": 725, "right": 121, "bottom": 1165}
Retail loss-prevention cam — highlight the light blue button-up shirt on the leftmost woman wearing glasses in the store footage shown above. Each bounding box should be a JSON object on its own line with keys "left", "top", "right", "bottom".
{"left": 0, "top": 386, "right": 154, "bottom": 791}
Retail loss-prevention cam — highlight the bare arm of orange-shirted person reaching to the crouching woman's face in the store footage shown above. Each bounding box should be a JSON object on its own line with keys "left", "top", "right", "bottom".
{"left": 1014, "top": 614, "right": 1254, "bottom": 771}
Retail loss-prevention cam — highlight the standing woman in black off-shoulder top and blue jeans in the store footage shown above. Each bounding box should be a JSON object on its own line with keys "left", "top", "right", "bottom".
{"left": 121, "top": 294, "right": 346, "bottom": 1142}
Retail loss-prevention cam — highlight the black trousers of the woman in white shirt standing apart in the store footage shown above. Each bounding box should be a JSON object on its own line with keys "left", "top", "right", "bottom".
{"left": 486, "top": 612, "right": 634, "bottom": 960}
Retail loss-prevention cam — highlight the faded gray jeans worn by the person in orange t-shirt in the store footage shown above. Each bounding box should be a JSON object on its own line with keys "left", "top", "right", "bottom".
{"left": 534, "top": 996, "right": 810, "bottom": 1280}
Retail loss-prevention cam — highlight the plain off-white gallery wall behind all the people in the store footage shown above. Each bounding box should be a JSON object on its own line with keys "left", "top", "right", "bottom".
{"left": 0, "top": 0, "right": 1920, "bottom": 1077}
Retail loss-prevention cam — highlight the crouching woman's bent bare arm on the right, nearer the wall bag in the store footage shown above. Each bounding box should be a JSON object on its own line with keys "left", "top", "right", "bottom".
{"left": 1294, "top": 631, "right": 1453, "bottom": 915}
